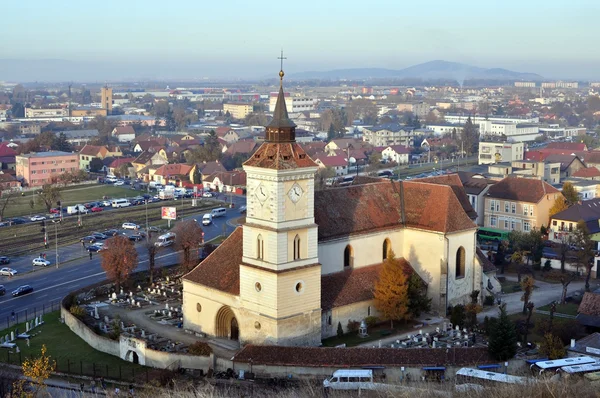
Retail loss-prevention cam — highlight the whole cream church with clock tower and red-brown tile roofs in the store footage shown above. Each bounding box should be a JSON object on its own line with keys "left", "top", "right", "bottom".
{"left": 183, "top": 67, "right": 495, "bottom": 346}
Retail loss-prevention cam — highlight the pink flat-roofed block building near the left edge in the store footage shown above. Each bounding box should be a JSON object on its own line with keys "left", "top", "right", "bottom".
{"left": 15, "top": 151, "right": 79, "bottom": 187}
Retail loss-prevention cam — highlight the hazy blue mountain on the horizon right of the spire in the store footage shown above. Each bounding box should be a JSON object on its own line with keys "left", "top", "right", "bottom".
{"left": 290, "top": 60, "right": 543, "bottom": 82}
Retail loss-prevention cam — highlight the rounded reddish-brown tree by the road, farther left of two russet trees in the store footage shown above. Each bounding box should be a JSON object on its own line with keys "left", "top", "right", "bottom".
{"left": 100, "top": 235, "right": 138, "bottom": 290}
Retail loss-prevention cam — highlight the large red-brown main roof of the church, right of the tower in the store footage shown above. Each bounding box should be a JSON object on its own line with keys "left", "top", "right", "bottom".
{"left": 315, "top": 181, "right": 475, "bottom": 240}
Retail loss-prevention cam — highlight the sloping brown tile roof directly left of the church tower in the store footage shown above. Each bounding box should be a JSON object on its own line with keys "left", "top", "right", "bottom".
{"left": 183, "top": 227, "right": 243, "bottom": 296}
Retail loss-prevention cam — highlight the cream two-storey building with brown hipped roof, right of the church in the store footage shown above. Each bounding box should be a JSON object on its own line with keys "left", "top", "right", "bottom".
{"left": 484, "top": 177, "right": 562, "bottom": 232}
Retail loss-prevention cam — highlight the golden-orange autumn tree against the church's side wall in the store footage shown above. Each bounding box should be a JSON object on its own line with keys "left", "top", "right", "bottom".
{"left": 374, "top": 251, "right": 410, "bottom": 329}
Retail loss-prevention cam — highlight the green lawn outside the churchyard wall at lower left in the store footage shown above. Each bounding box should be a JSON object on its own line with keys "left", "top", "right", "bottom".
{"left": 0, "top": 311, "right": 148, "bottom": 380}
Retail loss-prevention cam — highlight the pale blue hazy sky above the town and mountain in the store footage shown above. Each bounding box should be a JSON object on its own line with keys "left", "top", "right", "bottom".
{"left": 0, "top": 0, "right": 600, "bottom": 81}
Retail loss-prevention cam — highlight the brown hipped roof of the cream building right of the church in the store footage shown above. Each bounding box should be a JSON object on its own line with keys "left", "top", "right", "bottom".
{"left": 487, "top": 177, "right": 560, "bottom": 203}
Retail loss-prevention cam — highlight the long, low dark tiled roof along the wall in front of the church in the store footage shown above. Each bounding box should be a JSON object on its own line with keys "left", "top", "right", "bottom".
{"left": 234, "top": 344, "right": 492, "bottom": 368}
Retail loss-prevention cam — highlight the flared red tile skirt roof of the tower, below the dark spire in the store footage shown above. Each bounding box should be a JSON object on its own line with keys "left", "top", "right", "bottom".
{"left": 244, "top": 142, "right": 317, "bottom": 170}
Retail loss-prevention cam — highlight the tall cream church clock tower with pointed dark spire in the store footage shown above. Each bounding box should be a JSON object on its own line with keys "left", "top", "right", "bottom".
{"left": 240, "top": 61, "right": 321, "bottom": 346}
